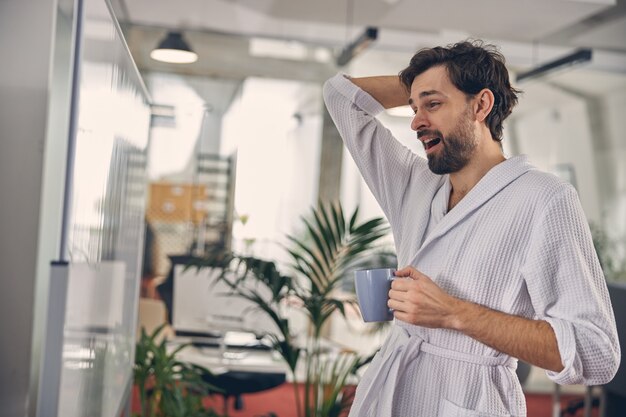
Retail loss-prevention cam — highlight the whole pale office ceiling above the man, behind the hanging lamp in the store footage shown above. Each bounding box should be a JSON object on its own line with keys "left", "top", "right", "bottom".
{"left": 111, "top": 0, "right": 626, "bottom": 80}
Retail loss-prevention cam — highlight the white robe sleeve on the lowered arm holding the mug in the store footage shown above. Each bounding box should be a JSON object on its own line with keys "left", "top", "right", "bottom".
{"left": 522, "top": 184, "right": 621, "bottom": 385}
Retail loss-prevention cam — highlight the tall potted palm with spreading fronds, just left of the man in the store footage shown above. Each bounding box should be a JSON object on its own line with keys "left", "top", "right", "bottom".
{"left": 194, "top": 200, "right": 389, "bottom": 417}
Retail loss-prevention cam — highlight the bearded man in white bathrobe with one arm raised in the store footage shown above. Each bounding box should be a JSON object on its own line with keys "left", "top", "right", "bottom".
{"left": 324, "top": 41, "right": 620, "bottom": 417}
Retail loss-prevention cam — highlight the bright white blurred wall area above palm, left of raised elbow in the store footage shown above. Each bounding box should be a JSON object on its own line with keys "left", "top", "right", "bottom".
{"left": 221, "top": 78, "right": 322, "bottom": 260}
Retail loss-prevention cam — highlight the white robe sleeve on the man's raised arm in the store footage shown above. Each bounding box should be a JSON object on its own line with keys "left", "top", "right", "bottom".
{"left": 324, "top": 74, "right": 430, "bottom": 231}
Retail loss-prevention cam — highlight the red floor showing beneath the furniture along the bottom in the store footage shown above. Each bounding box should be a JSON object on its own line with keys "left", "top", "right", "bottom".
{"left": 128, "top": 384, "right": 598, "bottom": 417}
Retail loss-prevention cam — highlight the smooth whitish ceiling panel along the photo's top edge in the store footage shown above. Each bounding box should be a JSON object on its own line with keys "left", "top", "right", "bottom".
{"left": 122, "top": 0, "right": 614, "bottom": 46}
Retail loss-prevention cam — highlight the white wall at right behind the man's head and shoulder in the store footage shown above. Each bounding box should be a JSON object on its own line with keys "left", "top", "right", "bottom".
{"left": 514, "top": 77, "right": 626, "bottom": 268}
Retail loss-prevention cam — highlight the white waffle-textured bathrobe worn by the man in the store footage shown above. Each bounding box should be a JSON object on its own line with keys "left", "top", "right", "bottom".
{"left": 324, "top": 74, "right": 620, "bottom": 417}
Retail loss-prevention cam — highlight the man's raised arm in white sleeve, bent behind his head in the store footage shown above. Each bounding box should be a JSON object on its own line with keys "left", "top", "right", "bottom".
{"left": 324, "top": 74, "right": 437, "bottom": 245}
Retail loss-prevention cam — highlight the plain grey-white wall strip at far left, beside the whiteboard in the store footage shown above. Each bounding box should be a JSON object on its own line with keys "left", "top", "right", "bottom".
{"left": 0, "top": 0, "right": 65, "bottom": 417}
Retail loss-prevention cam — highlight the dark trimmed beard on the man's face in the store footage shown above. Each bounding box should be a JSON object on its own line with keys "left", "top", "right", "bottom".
{"left": 420, "top": 108, "right": 478, "bottom": 175}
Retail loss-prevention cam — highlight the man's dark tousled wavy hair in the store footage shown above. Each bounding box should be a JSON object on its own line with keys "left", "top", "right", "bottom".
{"left": 399, "top": 40, "right": 521, "bottom": 142}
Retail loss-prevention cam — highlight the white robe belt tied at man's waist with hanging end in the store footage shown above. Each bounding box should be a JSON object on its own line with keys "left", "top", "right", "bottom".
{"left": 350, "top": 325, "right": 517, "bottom": 417}
